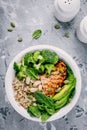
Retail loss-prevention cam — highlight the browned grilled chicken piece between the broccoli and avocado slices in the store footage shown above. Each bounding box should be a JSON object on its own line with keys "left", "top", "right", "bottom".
{"left": 41, "top": 61, "right": 67, "bottom": 96}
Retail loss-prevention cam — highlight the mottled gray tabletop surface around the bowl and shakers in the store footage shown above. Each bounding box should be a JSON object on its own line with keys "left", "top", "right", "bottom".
{"left": 0, "top": 0, "right": 87, "bottom": 130}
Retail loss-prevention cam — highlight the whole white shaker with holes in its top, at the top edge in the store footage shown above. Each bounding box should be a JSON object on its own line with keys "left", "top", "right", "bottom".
{"left": 54, "top": 0, "right": 80, "bottom": 22}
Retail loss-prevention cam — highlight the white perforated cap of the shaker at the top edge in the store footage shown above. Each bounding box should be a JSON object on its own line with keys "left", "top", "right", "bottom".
{"left": 57, "top": 0, "right": 80, "bottom": 15}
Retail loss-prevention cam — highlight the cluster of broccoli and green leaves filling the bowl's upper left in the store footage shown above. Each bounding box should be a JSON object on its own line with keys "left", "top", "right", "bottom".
{"left": 14, "top": 50, "right": 59, "bottom": 80}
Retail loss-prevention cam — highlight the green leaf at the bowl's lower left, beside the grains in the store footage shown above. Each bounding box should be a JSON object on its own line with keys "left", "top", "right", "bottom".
{"left": 27, "top": 106, "right": 41, "bottom": 118}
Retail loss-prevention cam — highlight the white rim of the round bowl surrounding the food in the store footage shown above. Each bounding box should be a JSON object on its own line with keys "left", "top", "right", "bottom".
{"left": 5, "top": 45, "right": 81, "bottom": 122}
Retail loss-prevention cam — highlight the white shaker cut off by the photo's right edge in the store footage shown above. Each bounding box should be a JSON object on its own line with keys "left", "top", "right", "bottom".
{"left": 77, "top": 16, "right": 87, "bottom": 43}
